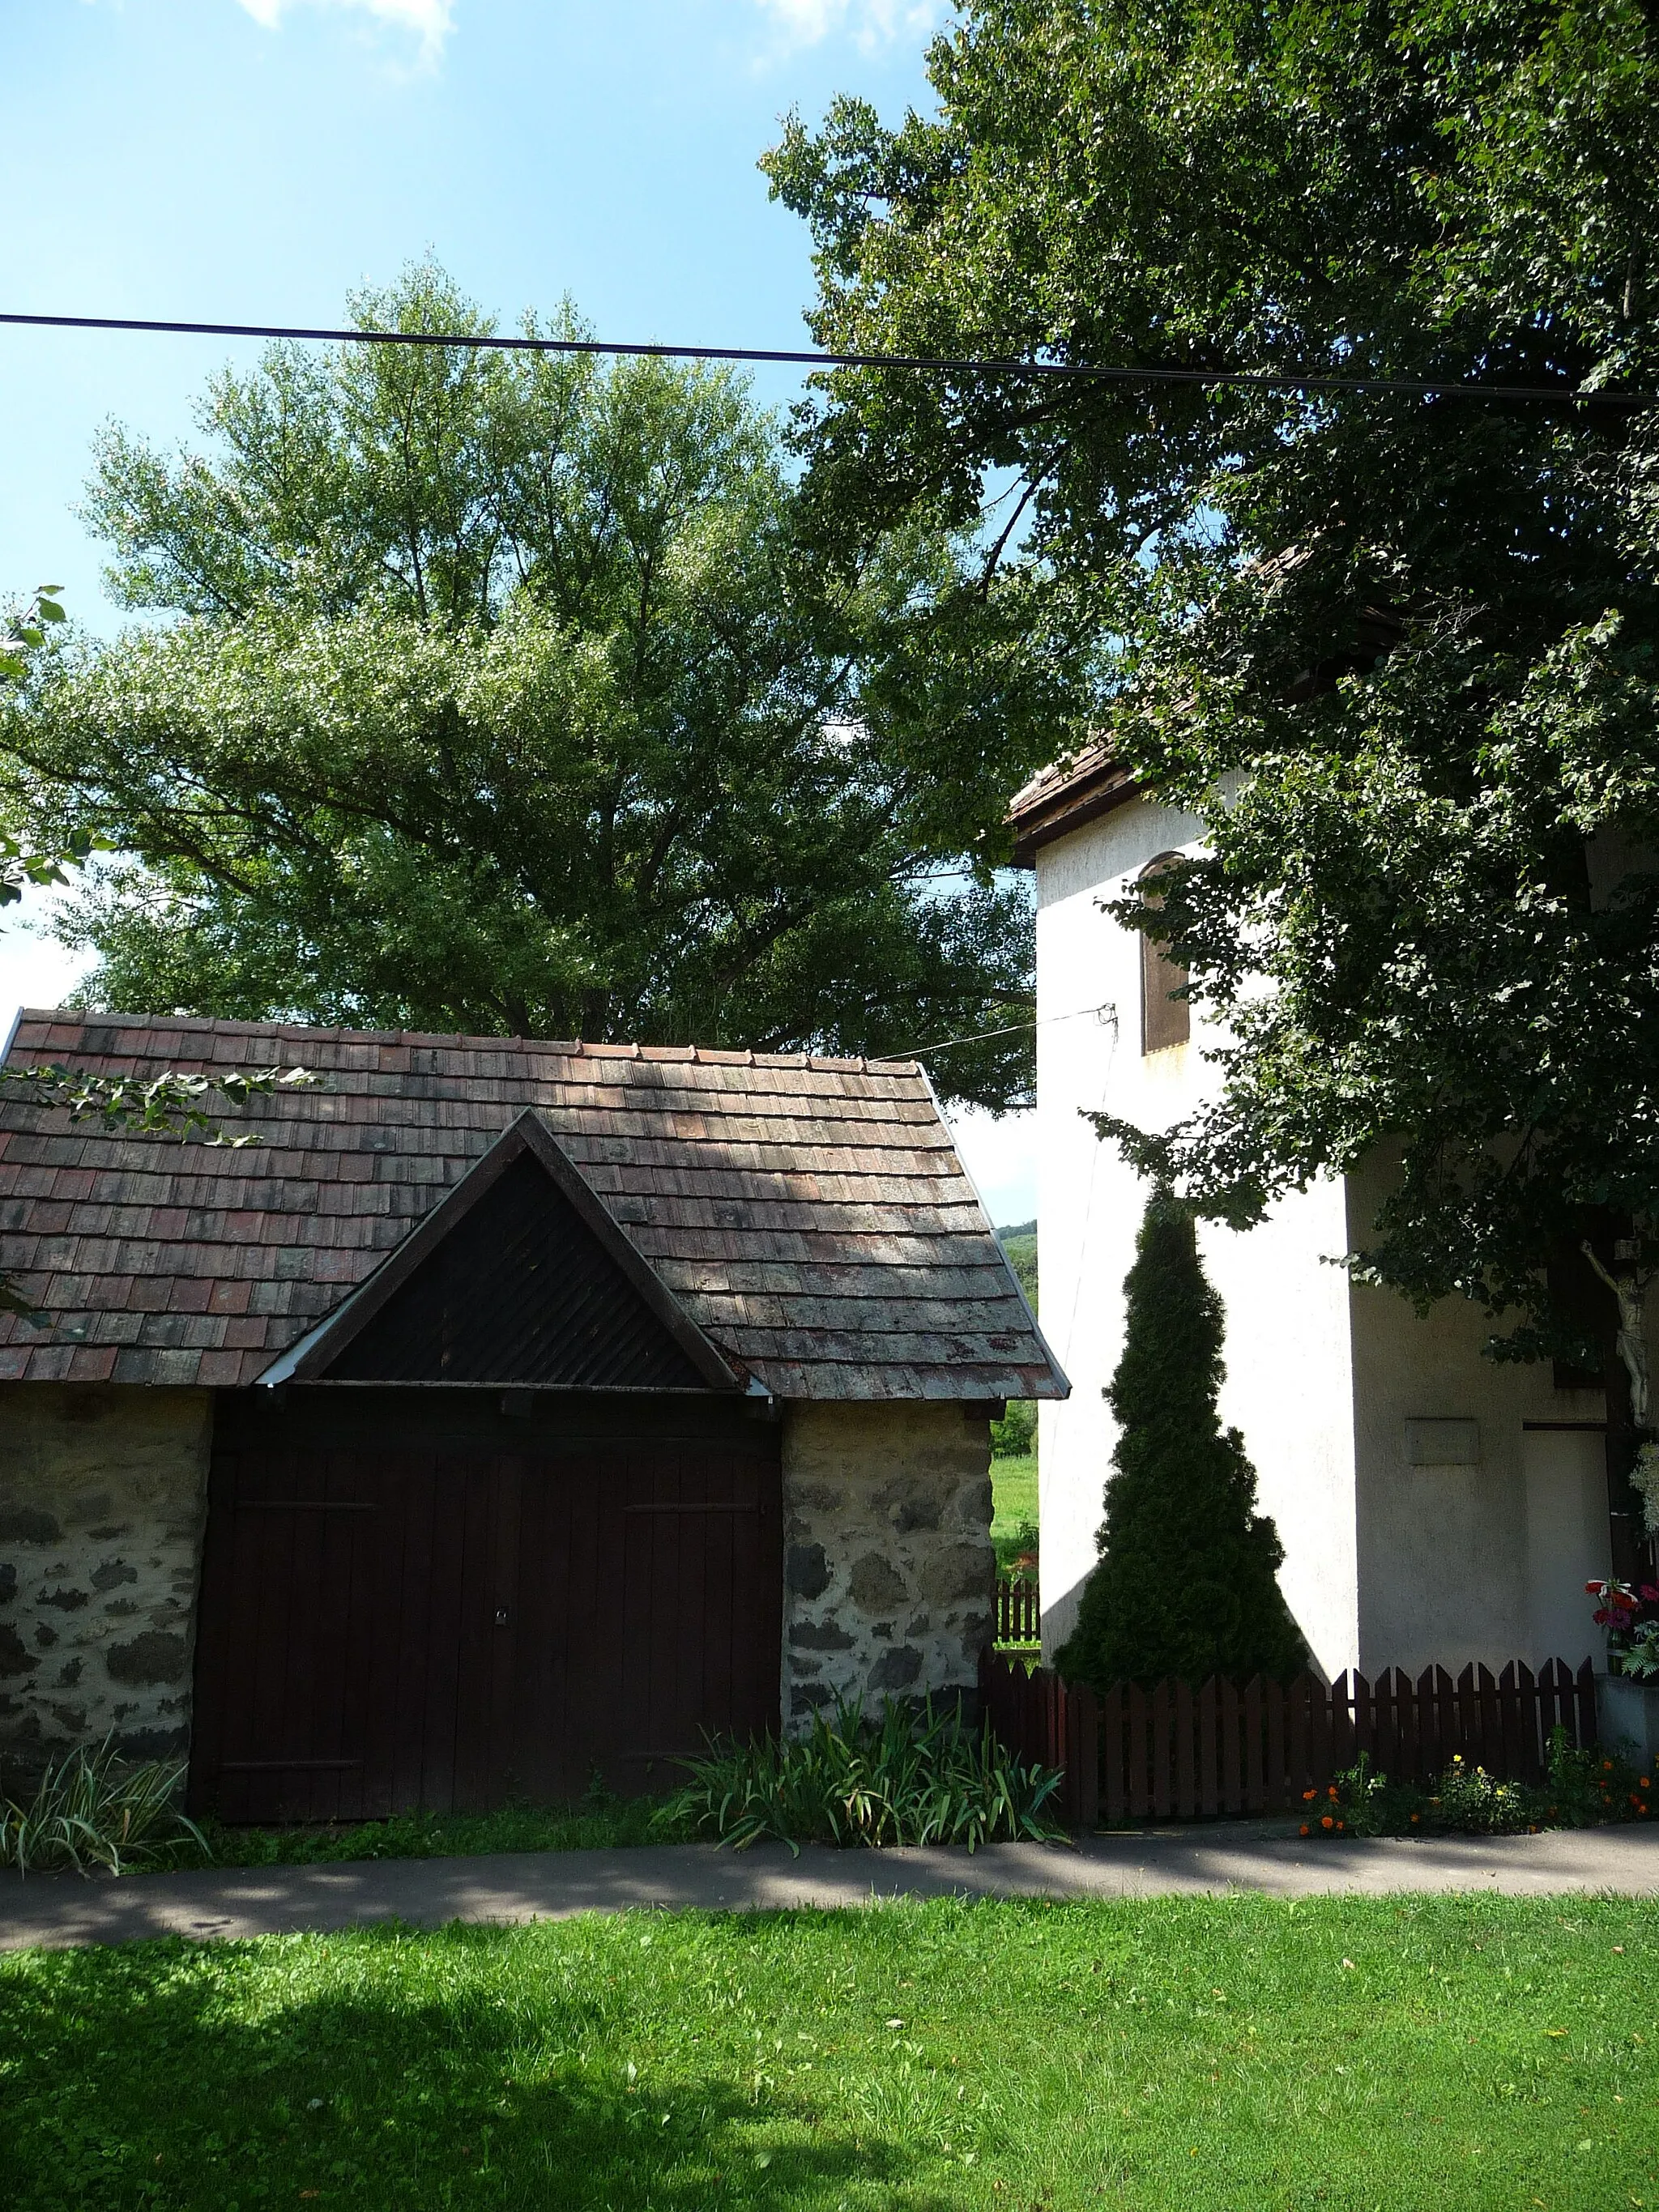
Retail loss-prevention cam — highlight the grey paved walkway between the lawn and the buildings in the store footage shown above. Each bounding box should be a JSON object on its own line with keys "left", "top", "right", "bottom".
{"left": 0, "top": 1822, "right": 1659, "bottom": 1951}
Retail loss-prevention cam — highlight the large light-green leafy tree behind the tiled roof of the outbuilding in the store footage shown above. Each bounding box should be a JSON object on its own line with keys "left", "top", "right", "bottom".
{"left": 0, "top": 266, "right": 1092, "bottom": 1106}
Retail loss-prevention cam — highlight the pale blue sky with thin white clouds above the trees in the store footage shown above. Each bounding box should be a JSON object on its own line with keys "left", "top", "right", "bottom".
{"left": 0, "top": 0, "right": 1035, "bottom": 1219}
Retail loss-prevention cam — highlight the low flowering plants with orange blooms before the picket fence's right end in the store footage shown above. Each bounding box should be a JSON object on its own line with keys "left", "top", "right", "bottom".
{"left": 1301, "top": 1728, "right": 1653, "bottom": 1836}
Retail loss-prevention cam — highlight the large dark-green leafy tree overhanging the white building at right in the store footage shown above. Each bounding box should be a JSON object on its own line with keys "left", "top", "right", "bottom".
{"left": 770, "top": 0, "right": 1659, "bottom": 1577}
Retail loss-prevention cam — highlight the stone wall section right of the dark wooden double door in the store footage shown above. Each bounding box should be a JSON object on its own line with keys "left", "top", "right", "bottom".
{"left": 783, "top": 1402, "right": 996, "bottom": 1730}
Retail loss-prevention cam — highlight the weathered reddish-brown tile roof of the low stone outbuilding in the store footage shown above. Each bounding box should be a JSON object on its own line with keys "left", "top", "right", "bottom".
{"left": 0, "top": 1011, "right": 1066, "bottom": 1398}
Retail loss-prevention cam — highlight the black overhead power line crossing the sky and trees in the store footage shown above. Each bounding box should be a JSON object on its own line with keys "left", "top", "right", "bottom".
{"left": 0, "top": 312, "right": 1659, "bottom": 407}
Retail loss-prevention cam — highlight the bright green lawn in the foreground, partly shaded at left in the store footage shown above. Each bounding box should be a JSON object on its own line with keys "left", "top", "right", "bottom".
{"left": 0, "top": 1895, "right": 1659, "bottom": 2212}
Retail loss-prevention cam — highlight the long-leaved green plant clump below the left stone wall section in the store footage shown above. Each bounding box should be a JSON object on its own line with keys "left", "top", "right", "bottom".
{"left": 0, "top": 1737, "right": 212, "bottom": 1873}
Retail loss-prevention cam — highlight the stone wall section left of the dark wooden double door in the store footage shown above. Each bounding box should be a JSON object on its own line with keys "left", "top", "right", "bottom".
{"left": 0, "top": 1383, "right": 212, "bottom": 1779}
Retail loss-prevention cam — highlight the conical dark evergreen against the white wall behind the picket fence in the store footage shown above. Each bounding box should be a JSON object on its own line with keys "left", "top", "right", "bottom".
{"left": 1056, "top": 1190, "right": 1307, "bottom": 1688}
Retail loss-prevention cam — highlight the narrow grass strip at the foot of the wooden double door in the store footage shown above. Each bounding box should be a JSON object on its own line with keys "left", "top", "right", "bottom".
{"left": 201, "top": 1794, "right": 675, "bottom": 1867}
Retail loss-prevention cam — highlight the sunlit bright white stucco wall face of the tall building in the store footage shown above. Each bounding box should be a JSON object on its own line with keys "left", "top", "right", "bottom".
{"left": 1038, "top": 801, "right": 1358, "bottom": 1673}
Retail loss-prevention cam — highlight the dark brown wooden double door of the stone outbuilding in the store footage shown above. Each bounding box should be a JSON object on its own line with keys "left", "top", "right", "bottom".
{"left": 190, "top": 1387, "right": 783, "bottom": 1821}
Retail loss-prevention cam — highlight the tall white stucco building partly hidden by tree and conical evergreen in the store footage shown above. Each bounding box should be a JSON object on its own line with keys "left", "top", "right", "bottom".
{"left": 1011, "top": 745, "right": 1608, "bottom": 1677}
